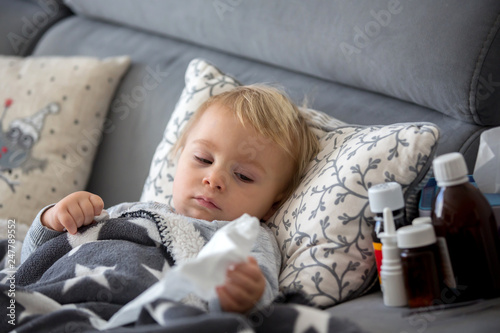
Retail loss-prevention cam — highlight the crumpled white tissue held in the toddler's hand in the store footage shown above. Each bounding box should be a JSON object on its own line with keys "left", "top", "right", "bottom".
{"left": 100, "top": 214, "right": 259, "bottom": 329}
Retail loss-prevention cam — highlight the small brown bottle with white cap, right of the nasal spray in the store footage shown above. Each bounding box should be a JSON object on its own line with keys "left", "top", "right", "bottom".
{"left": 397, "top": 223, "right": 443, "bottom": 308}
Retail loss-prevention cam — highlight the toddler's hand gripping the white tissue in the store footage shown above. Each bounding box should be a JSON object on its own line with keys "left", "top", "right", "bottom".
{"left": 216, "top": 257, "right": 266, "bottom": 313}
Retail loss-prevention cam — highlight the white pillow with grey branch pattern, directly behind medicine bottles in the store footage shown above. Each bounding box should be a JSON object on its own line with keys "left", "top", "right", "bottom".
{"left": 267, "top": 124, "right": 439, "bottom": 307}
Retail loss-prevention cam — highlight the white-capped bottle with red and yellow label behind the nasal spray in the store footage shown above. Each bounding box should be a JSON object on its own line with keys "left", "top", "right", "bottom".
{"left": 368, "top": 182, "right": 406, "bottom": 284}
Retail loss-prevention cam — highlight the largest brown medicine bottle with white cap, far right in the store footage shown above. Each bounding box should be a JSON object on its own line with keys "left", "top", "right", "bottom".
{"left": 431, "top": 153, "right": 500, "bottom": 303}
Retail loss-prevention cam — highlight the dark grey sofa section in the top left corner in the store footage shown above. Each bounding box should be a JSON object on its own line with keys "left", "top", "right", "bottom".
{"left": 0, "top": 0, "right": 71, "bottom": 56}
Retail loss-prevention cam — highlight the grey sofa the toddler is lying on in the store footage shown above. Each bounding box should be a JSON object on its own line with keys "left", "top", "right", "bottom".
{"left": 0, "top": 0, "right": 500, "bottom": 332}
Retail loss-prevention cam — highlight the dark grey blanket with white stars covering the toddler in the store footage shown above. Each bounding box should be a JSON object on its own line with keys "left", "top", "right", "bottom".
{"left": 0, "top": 211, "right": 361, "bottom": 333}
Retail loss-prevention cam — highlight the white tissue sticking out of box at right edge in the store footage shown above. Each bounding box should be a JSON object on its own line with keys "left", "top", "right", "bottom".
{"left": 473, "top": 127, "right": 500, "bottom": 193}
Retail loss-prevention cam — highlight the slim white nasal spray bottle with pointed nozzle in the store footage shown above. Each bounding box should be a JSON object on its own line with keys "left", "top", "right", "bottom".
{"left": 379, "top": 208, "right": 408, "bottom": 306}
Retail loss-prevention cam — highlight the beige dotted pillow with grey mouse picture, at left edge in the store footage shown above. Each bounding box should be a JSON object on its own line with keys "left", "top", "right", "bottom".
{"left": 0, "top": 56, "right": 130, "bottom": 236}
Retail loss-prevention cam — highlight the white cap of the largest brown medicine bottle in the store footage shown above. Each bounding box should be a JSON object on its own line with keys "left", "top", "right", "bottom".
{"left": 432, "top": 153, "right": 469, "bottom": 187}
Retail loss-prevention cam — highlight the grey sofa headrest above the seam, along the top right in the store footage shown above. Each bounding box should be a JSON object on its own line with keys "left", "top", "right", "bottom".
{"left": 66, "top": 0, "right": 500, "bottom": 125}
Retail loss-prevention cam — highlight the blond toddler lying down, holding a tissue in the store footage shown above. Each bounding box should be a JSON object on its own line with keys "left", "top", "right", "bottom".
{"left": 22, "top": 85, "right": 318, "bottom": 313}
